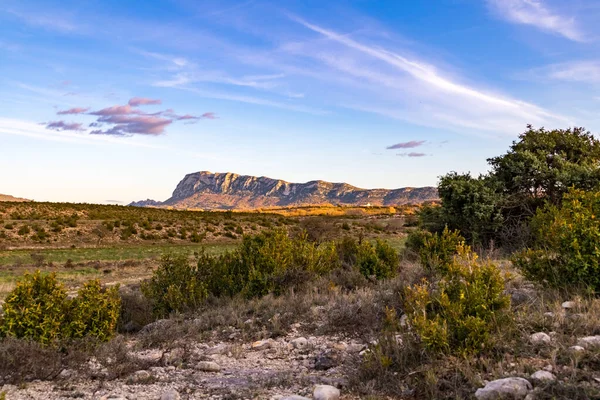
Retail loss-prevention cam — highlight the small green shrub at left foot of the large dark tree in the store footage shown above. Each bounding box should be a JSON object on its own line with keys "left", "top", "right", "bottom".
{"left": 419, "top": 228, "right": 465, "bottom": 273}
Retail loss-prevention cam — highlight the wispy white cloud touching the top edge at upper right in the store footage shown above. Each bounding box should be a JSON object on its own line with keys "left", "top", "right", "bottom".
{"left": 487, "top": 0, "right": 586, "bottom": 42}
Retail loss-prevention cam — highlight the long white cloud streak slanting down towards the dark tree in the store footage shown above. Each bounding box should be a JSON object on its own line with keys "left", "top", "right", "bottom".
{"left": 288, "top": 17, "right": 570, "bottom": 134}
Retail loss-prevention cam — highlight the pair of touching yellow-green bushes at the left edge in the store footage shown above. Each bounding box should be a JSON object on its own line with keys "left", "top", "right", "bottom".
{"left": 0, "top": 271, "right": 120, "bottom": 344}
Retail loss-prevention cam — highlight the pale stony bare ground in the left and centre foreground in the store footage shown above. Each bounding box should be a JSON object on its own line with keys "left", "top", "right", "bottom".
{"left": 0, "top": 323, "right": 366, "bottom": 400}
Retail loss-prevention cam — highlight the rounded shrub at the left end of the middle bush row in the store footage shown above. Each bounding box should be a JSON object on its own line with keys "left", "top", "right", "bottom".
{"left": 141, "top": 255, "right": 208, "bottom": 316}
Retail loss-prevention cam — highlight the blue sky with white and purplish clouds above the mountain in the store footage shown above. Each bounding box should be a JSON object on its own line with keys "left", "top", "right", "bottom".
{"left": 0, "top": 0, "right": 600, "bottom": 204}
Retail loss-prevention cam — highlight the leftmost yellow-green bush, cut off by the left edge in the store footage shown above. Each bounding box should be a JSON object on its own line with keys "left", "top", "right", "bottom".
{"left": 0, "top": 271, "right": 68, "bottom": 343}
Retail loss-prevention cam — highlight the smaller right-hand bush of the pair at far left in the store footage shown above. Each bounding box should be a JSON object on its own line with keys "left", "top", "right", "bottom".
{"left": 65, "top": 280, "right": 121, "bottom": 341}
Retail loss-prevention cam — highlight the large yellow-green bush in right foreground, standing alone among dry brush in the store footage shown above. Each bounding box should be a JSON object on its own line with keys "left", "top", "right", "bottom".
{"left": 405, "top": 245, "right": 510, "bottom": 354}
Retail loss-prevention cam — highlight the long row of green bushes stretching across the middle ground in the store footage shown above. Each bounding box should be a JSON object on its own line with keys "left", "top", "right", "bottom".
{"left": 142, "top": 229, "right": 399, "bottom": 306}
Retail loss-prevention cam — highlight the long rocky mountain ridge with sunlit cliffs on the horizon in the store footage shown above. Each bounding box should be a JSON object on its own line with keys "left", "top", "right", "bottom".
{"left": 130, "top": 171, "right": 438, "bottom": 210}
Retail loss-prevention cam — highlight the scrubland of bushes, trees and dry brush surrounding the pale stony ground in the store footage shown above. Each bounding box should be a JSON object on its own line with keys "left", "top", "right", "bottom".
{"left": 0, "top": 127, "right": 600, "bottom": 399}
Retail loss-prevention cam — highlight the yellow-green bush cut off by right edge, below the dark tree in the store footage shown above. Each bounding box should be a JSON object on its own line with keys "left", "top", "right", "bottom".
{"left": 513, "top": 189, "right": 600, "bottom": 292}
